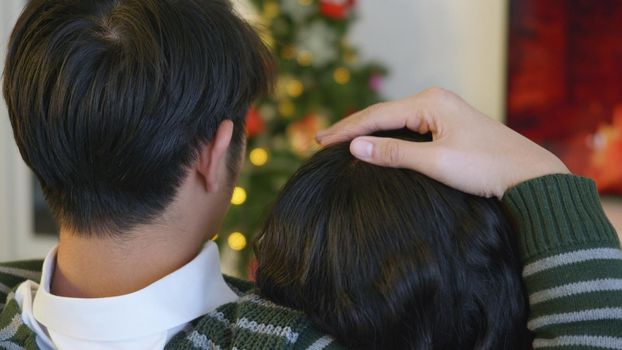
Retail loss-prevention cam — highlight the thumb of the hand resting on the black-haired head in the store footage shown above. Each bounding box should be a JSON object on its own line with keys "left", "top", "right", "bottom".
{"left": 350, "top": 136, "right": 435, "bottom": 173}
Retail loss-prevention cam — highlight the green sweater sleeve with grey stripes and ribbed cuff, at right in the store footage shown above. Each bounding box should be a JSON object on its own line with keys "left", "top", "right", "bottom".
{"left": 503, "top": 175, "right": 622, "bottom": 349}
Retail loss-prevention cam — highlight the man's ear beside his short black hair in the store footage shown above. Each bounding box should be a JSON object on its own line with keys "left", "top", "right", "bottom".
{"left": 196, "top": 120, "right": 233, "bottom": 192}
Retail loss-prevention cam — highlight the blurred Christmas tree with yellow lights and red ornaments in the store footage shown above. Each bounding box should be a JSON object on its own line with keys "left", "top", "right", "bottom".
{"left": 216, "top": 0, "right": 385, "bottom": 277}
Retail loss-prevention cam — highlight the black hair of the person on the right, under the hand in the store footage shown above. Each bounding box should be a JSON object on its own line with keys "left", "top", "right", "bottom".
{"left": 255, "top": 132, "right": 530, "bottom": 349}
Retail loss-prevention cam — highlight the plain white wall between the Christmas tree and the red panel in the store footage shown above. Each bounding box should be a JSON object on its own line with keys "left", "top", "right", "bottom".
{"left": 351, "top": 0, "right": 508, "bottom": 118}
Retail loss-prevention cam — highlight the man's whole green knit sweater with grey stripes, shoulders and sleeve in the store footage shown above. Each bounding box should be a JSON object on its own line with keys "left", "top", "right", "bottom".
{"left": 0, "top": 175, "right": 622, "bottom": 350}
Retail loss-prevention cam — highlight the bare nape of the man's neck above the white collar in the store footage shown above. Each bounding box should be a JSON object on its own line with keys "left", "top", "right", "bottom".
{"left": 50, "top": 227, "right": 204, "bottom": 298}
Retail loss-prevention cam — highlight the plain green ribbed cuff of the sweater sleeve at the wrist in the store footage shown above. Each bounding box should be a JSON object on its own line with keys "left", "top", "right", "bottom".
{"left": 503, "top": 174, "right": 620, "bottom": 263}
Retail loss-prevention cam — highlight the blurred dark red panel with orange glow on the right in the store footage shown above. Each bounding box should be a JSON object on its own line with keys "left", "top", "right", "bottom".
{"left": 507, "top": 0, "right": 622, "bottom": 195}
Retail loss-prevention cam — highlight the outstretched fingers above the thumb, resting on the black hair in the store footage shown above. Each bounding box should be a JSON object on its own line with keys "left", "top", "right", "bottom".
{"left": 317, "top": 100, "right": 416, "bottom": 146}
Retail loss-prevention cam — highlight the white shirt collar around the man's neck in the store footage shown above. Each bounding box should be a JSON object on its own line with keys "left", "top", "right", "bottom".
{"left": 33, "top": 242, "right": 238, "bottom": 342}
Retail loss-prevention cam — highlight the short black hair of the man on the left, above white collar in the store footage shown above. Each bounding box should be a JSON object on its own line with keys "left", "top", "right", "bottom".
{"left": 4, "top": 0, "right": 273, "bottom": 233}
